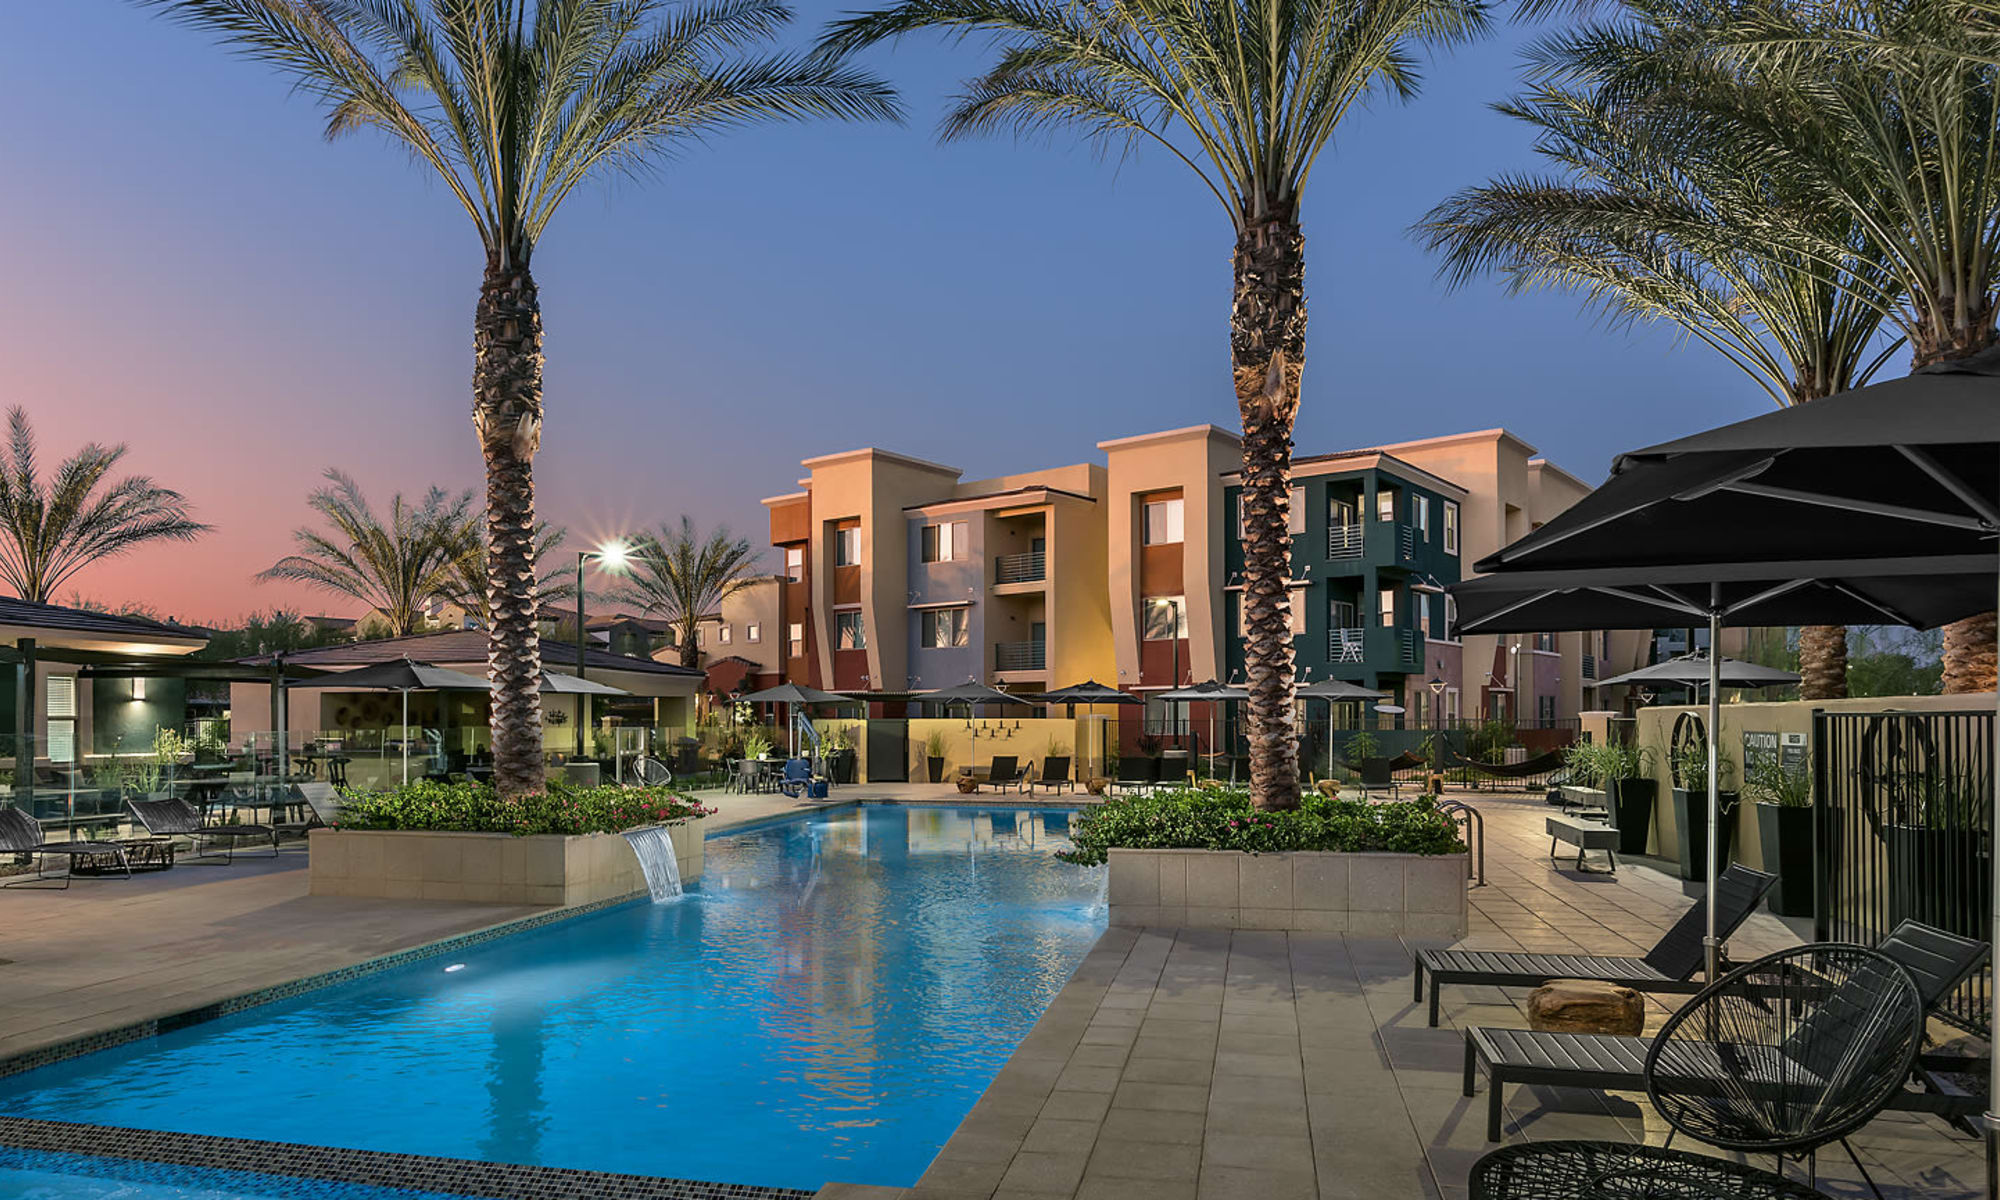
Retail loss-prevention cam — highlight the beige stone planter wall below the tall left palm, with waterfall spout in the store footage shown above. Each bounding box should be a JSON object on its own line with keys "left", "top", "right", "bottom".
{"left": 308, "top": 822, "right": 702, "bottom": 904}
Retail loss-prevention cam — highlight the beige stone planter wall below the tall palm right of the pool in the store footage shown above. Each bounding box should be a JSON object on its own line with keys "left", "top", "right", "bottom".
{"left": 1110, "top": 850, "right": 1466, "bottom": 938}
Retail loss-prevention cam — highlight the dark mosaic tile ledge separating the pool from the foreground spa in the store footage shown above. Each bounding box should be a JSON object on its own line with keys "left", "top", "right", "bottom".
{"left": 0, "top": 1116, "right": 812, "bottom": 1200}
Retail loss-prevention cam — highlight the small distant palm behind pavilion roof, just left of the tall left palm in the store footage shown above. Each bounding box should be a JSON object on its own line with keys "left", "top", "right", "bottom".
{"left": 258, "top": 470, "right": 478, "bottom": 638}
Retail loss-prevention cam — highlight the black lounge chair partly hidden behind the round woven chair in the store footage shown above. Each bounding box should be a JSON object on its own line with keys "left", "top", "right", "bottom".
{"left": 1464, "top": 920, "right": 1986, "bottom": 1142}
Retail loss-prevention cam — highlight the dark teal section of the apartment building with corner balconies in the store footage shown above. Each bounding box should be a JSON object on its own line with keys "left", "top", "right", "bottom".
{"left": 1224, "top": 452, "right": 1466, "bottom": 706}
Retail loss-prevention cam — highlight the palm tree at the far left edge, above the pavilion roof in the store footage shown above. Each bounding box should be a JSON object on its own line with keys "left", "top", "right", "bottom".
{"left": 0, "top": 408, "right": 210, "bottom": 604}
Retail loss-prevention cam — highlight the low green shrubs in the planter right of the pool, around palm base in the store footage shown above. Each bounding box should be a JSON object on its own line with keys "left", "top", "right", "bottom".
{"left": 1056, "top": 788, "right": 1464, "bottom": 866}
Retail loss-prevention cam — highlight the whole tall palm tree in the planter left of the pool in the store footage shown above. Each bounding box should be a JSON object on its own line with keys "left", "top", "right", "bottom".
{"left": 154, "top": 0, "right": 896, "bottom": 796}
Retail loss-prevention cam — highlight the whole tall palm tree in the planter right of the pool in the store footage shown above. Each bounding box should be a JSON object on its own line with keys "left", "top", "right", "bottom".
{"left": 820, "top": 0, "right": 1486, "bottom": 808}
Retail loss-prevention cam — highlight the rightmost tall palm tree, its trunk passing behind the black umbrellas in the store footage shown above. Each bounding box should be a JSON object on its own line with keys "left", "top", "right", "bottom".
{"left": 1566, "top": 0, "right": 2000, "bottom": 692}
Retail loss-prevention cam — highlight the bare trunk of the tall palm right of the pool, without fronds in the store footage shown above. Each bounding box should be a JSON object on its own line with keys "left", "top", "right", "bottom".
{"left": 1230, "top": 206, "right": 1306, "bottom": 808}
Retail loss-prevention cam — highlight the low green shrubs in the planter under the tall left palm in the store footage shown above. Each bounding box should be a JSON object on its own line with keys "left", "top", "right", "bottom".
{"left": 340, "top": 780, "right": 714, "bottom": 836}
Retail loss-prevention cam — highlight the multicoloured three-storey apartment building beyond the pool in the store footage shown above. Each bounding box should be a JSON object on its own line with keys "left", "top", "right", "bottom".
{"left": 764, "top": 424, "right": 1652, "bottom": 722}
